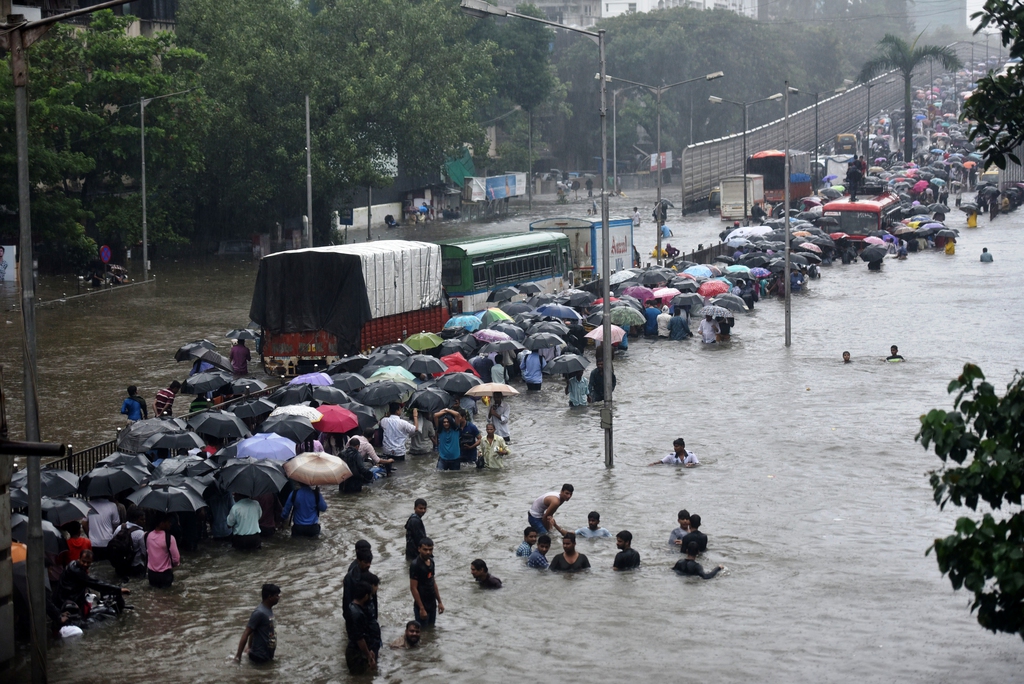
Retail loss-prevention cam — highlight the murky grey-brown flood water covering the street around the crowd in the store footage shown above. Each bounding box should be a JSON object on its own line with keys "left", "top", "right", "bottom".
{"left": 0, "top": 188, "right": 1024, "bottom": 683}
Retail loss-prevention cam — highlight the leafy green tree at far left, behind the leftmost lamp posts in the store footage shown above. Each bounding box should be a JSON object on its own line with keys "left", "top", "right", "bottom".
{"left": 0, "top": 10, "right": 207, "bottom": 268}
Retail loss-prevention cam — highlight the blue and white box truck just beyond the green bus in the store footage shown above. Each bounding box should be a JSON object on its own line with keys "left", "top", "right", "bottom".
{"left": 529, "top": 218, "right": 633, "bottom": 285}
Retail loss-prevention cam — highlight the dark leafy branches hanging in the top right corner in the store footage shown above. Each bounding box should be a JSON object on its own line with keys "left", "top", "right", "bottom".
{"left": 964, "top": 0, "right": 1024, "bottom": 169}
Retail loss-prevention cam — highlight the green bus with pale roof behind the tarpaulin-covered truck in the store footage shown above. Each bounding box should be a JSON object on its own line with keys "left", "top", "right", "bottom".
{"left": 441, "top": 232, "right": 571, "bottom": 313}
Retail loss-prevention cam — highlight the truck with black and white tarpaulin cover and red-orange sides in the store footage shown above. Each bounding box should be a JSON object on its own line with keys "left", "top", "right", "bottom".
{"left": 249, "top": 240, "right": 449, "bottom": 377}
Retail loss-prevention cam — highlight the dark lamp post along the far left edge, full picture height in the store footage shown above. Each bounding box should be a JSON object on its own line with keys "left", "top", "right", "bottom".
{"left": 0, "top": 0, "right": 136, "bottom": 682}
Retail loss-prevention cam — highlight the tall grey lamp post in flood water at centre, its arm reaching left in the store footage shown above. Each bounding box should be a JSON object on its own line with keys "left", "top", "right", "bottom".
{"left": 459, "top": 0, "right": 614, "bottom": 468}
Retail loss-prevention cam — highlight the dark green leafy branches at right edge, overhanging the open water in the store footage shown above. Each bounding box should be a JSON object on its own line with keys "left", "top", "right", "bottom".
{"left": 916, "top": 364, "right": 1024, "bottom": 638}
